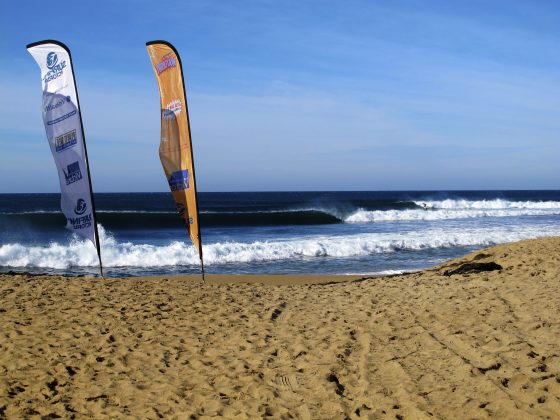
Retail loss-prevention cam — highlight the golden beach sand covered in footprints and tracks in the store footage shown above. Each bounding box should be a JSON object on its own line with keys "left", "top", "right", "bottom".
{"left": 0, "top": 238, "right": 560, "bottom": 419}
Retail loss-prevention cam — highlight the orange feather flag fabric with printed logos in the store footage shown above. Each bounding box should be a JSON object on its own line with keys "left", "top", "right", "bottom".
{"left": 146, "top": 41, "right": 203, "bottom": 262}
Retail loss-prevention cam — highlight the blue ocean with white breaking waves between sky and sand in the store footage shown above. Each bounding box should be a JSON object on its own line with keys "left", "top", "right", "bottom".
{"left": 0, "top": 191, "right": 560, "bottom": 277}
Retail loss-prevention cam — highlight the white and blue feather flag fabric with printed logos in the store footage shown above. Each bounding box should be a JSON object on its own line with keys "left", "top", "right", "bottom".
{"left": 27, "top": 40, "right": 101, "bottom": 274}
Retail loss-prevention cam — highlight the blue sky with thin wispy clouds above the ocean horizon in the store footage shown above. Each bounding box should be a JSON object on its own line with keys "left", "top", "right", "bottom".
{"left": 0, "top": 0, "right": 560, "bottom": 193}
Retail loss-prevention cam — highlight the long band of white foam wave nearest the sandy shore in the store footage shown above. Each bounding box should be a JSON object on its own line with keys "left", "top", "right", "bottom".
{"left": 0, "top": 225, "right": 560, "bottom": 269}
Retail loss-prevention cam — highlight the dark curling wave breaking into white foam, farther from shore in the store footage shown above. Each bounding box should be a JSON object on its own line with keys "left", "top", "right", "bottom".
{"left": 0, "top": 199, "right": 560, "bottom": 230}
